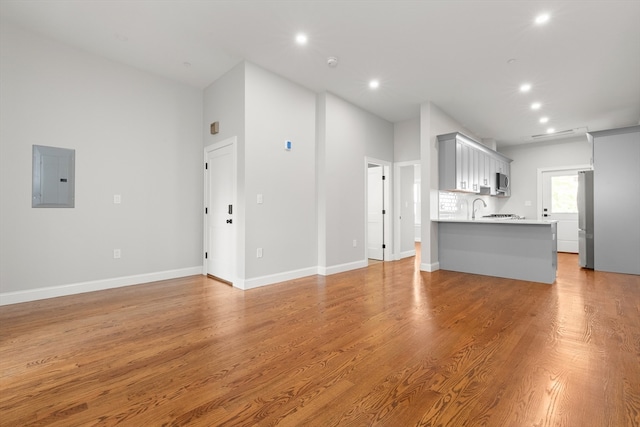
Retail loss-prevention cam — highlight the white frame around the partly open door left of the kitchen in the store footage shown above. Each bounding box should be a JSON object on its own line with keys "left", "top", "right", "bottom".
{"left": 364, "top": 157, "right": 394, "bottom": 261}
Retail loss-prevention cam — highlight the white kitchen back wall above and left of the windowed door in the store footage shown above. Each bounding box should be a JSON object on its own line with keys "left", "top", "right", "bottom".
{"left": 497, "top": 136, "right": 592, "bottom": 219}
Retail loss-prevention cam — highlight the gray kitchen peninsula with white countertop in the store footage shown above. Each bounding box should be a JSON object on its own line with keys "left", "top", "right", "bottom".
{"left": 435, "top": 219, "right": 558, "bottom": 284}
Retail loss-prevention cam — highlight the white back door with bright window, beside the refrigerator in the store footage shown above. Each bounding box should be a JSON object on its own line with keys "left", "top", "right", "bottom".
{"left": 541, "top": 169, "right": 581, "bottom": 253}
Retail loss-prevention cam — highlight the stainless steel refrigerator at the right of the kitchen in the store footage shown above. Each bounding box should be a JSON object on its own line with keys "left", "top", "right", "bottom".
{"left": 578, "top": 170, "right": 593, "bottom": 269}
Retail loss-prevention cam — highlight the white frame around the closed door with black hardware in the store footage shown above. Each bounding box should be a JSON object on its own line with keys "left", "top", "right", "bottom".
{"left": 202, "top": 136, "right": 243, "bottom": 287}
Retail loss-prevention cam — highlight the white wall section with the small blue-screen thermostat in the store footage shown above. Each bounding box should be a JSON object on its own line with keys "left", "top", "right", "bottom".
{"left": 245, "top": 63, "right": 318, "bottom": 279}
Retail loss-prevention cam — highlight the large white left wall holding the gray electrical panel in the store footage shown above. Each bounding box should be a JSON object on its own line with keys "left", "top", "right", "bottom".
{"left": 0, "top": 23, "right": 202, "bottom": 303}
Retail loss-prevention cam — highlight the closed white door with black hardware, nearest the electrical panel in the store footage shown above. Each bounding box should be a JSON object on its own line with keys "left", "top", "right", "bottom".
{"left": 205, "top": 145, "right": 236, "bottom": 283}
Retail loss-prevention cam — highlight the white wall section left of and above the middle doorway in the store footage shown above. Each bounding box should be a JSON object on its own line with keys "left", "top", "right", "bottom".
{"left": 317, "top": 93, "right": 393, "bottom": 273}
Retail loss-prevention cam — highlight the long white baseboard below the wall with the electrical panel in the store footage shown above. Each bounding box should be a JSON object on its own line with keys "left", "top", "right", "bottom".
{"left": 0, "top": 266, "right": 202, "bottom": 306}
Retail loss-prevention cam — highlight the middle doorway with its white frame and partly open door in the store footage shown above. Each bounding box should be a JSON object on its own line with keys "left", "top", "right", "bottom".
{"left": 366, "top": 159, "right": 391, "bottom": 261}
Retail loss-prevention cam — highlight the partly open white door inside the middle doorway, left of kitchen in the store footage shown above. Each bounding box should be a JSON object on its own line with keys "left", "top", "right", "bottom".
{"left": 367, "top": 163, "right": 384, "bottom": 261}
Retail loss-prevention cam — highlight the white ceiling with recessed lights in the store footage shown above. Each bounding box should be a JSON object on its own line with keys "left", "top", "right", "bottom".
{"left": 0, "top": 0, "right": 640, "bottom": 146}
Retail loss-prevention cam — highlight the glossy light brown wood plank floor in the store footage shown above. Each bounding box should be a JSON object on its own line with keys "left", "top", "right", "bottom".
{"left": 0, "top": 249, "right": 640, "bottom": 427}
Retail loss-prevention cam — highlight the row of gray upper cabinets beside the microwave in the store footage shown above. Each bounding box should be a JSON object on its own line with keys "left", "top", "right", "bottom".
{"left": 438, "top": 132, "right": 511, "bottom": 196}
